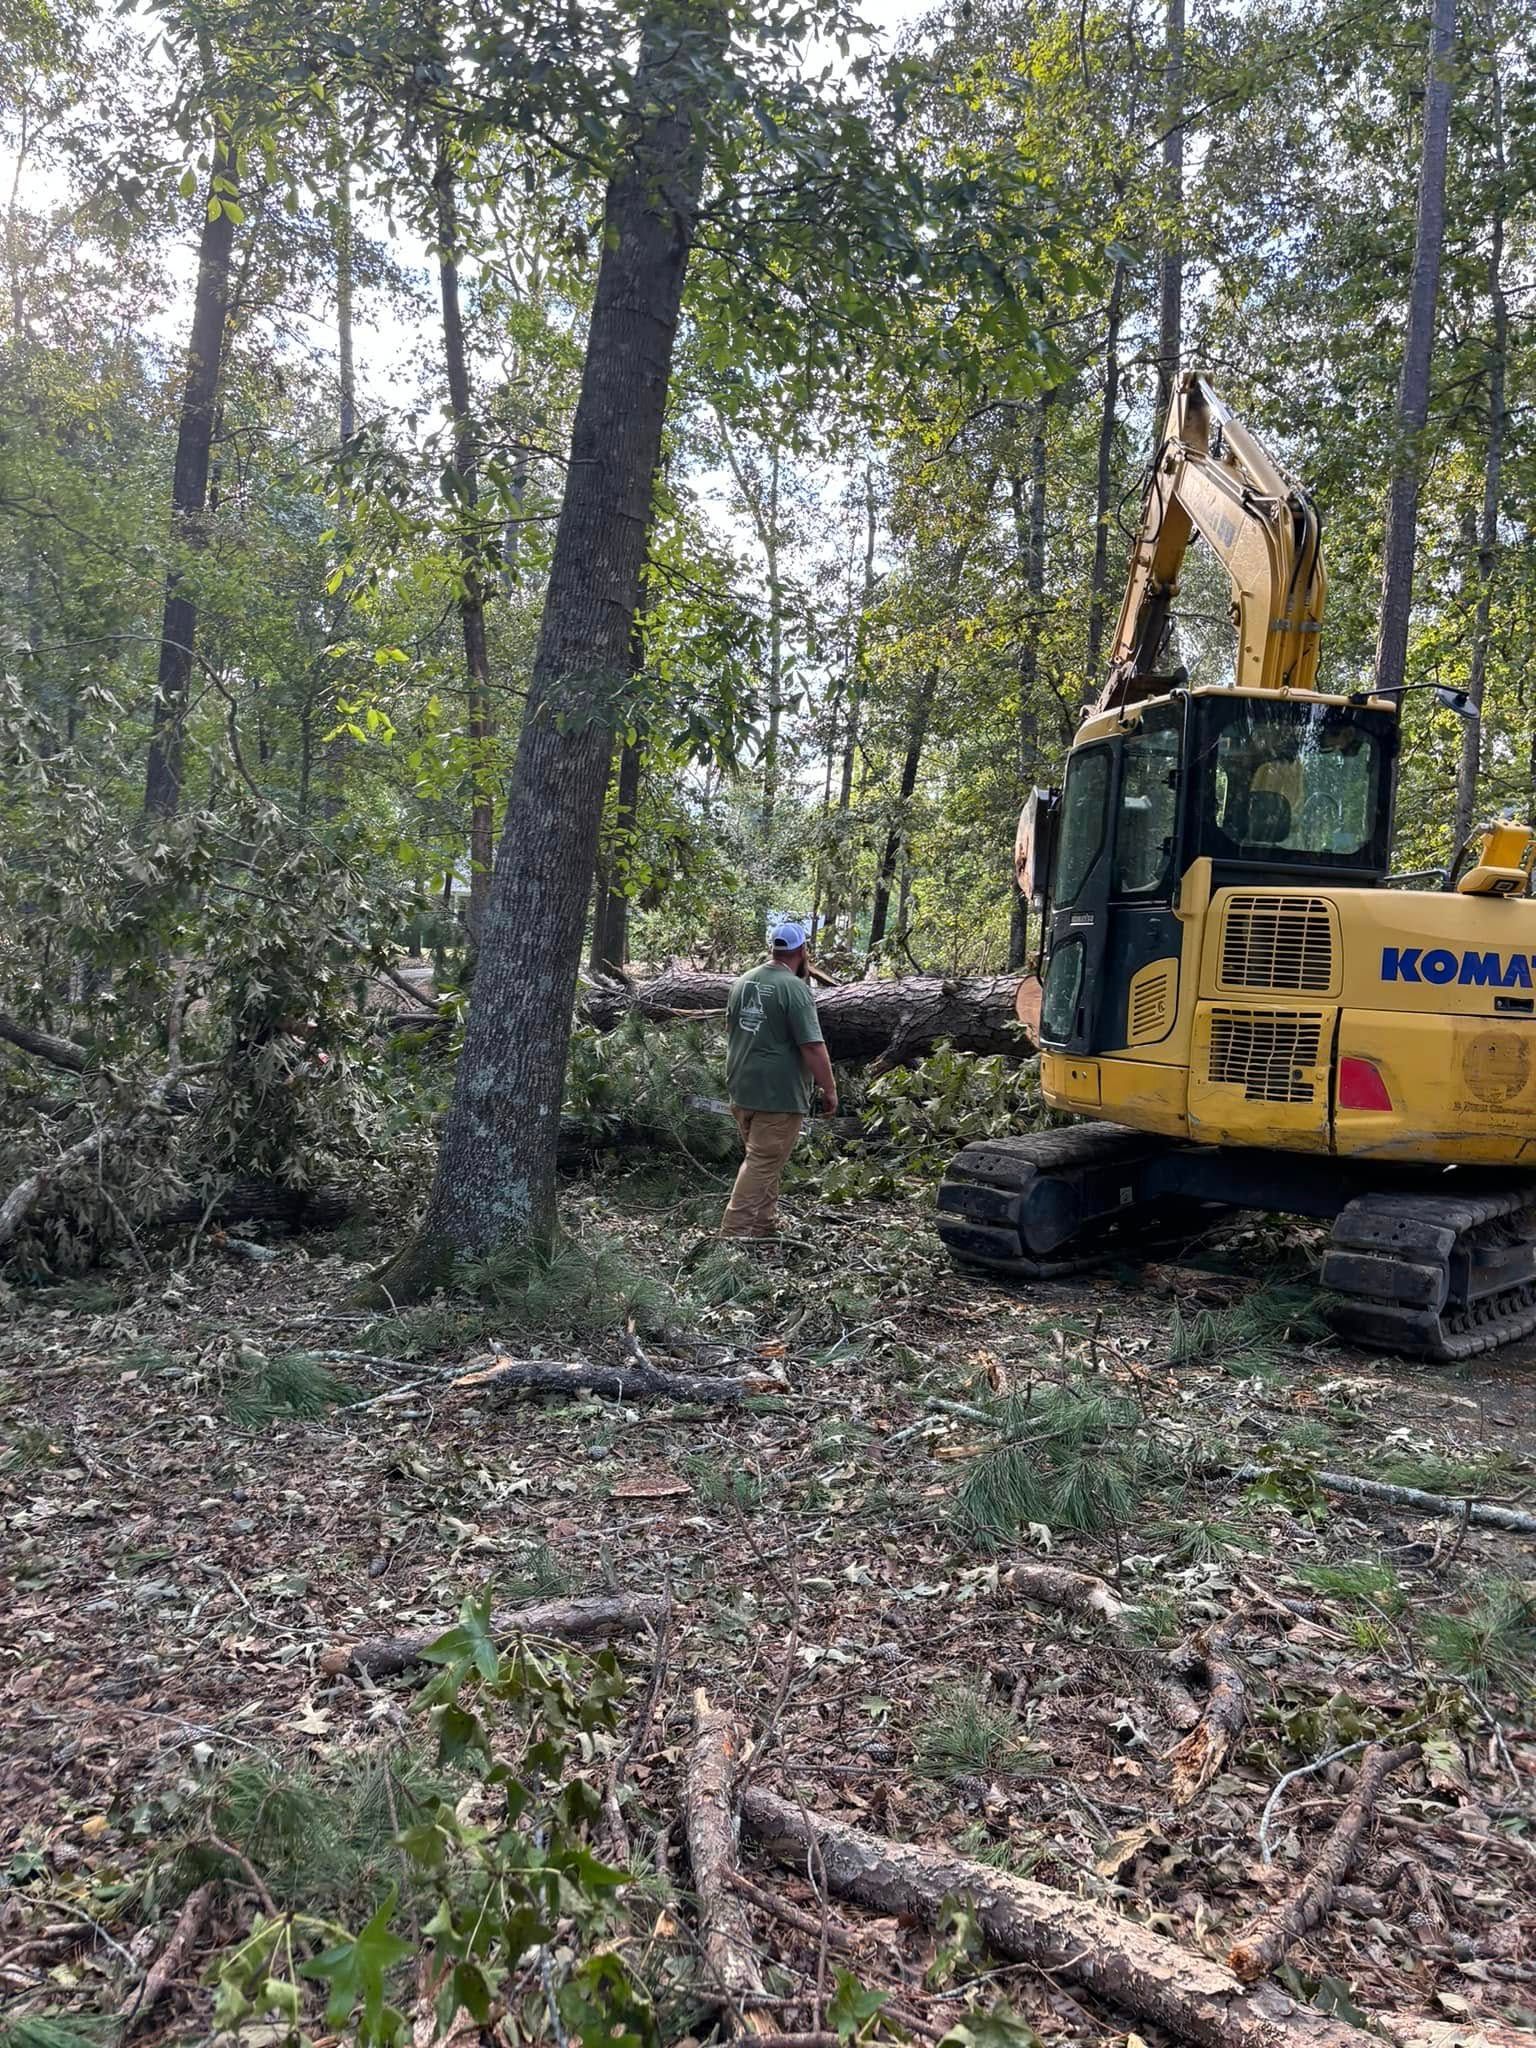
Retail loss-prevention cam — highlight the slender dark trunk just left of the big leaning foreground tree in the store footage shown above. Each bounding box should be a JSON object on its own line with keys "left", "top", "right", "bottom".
{"left": 432, "top": 139, "right": 496, "bottom": 952}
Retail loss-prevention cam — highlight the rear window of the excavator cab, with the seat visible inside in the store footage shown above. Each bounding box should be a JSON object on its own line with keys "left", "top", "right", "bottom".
{"left": 1200, "top": 696, "right": 1395, "bottom": 872}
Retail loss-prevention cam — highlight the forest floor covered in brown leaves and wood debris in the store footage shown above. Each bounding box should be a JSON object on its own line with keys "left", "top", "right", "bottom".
{"left": 0, "top": 1176, "right": 1536, "bottom": 2044}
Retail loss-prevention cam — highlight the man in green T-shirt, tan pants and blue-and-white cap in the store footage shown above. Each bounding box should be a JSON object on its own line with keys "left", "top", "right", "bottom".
{"left": 721, "top": 924, "right": 838, "bottom": 1237}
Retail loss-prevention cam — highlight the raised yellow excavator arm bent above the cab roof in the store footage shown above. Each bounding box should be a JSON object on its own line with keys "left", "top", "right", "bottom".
{"left": 1094, "top": 371, "right": 1325, "bottom": 711}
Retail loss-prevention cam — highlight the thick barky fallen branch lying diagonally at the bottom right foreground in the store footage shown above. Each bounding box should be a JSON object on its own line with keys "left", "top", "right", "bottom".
{"left": 741, "top": 1786, "right": 1378, "bottom": 2048}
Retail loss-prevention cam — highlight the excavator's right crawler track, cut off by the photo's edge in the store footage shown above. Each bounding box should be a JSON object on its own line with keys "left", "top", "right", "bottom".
{"left": 1321, "top": 1182, "right": 1536, "bottom": 1362}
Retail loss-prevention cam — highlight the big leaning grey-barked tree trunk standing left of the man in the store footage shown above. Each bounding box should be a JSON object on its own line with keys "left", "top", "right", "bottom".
{"left": 370, "top": 16, "right": 721, "bottom": 1296}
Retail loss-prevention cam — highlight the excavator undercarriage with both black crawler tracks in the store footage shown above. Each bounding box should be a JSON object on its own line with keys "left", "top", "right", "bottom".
{"left": 938, "top": 1124, "right": 1536, "bottom": 1362}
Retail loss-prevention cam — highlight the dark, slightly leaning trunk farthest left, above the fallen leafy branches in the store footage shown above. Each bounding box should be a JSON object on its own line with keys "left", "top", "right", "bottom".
{"left": 143, "top": 135, "right": 236, "bottom": 817}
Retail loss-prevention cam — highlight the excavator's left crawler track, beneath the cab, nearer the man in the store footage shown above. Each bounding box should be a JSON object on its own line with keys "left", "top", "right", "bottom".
{"left": 936, "top": 1124, "right": 1206, "bottom": 1280}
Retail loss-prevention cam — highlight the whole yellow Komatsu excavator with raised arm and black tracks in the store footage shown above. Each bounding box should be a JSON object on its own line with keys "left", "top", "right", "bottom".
{"left": 938, "top": 373, "right": 1536, "bottom": 1360}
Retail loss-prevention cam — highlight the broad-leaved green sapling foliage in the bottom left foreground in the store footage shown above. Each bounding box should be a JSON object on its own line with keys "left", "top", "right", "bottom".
{"left": 215, "top": 1593, "right": 657, "bottom": 2048}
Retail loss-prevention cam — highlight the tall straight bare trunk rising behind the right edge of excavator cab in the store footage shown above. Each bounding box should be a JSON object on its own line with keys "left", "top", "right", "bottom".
{"left": 1376, "top": 0, "right": 1456, "bottom": 692}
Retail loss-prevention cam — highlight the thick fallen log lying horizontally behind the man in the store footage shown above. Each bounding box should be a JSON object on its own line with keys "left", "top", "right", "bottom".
{"left": 582, "top": 967, "right": 1034, "bottom": 1067}
